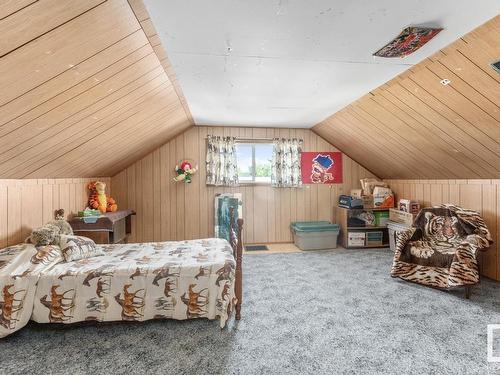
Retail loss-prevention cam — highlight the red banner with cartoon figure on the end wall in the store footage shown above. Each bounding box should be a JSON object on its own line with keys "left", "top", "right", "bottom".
{"left": 301, "top": 152, "right": 342, "bottom": 184}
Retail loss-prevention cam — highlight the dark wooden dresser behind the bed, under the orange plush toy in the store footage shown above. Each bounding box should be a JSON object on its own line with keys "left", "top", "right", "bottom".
{"left": 69, "top": 210, "right": 135, "bottom": 244}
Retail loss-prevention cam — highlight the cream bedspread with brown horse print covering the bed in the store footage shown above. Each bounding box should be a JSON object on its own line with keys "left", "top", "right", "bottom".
{"left": 0, "top": 238, "right": 236, "bottom": 337}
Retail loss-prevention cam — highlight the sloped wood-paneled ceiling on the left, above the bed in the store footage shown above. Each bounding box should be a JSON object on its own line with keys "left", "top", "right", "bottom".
{"left": 0, "top": 0, "right": 193, "bottom": 178}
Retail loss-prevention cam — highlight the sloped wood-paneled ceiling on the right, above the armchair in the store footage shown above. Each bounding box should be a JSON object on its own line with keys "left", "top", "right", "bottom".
{"left": 313, "top": 16, "right": 500, "bottom": 179}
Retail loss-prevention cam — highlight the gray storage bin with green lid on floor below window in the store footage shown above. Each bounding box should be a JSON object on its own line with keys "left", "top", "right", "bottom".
{"left": 290, "top": 221, "right": 340, "bottom": 250}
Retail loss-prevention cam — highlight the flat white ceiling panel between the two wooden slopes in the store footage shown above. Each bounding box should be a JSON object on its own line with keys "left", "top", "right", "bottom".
{"left": 145, "top": 0, "right": 500, "bottom": 127}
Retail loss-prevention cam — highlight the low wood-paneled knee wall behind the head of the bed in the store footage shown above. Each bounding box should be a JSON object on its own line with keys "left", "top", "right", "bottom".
{"left": 0, "top": 177, "right": 111, "bottom": 248}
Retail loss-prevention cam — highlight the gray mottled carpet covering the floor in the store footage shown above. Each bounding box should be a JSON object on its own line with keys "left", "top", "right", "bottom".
{"left": 0, "top": 250, "right": 500, "bottom": 375}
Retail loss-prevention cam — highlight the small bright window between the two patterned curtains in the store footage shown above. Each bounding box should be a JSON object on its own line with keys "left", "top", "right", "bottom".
{"left": 236, "top": 142, "right": 273, "bottom": 184}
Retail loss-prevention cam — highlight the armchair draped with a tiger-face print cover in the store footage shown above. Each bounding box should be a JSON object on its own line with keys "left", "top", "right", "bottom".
{"left": 391, "top": 204, "right": 493, "bottom": 298}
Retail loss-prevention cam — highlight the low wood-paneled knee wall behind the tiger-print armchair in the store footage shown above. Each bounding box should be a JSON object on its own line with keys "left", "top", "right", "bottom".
{"left": 386, "top": 180, "right": 500, "bottom": 281}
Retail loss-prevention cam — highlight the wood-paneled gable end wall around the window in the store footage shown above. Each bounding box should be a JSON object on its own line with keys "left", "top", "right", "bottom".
{"left": 112, "top": 126, "right": 372, "bottom": 243}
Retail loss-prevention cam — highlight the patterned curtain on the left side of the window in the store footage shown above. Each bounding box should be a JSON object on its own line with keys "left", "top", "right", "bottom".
{"left": 206, "top": 135, "right": 238, "bottom": 186}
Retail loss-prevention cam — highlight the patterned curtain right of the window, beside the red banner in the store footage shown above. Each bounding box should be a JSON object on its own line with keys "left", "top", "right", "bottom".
{"left": 271, "top": 138, "right": 303, "bottom": 187}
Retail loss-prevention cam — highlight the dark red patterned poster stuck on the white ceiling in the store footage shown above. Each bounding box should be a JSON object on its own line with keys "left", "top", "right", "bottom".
{"left": 373, "top": 27, "right": 443, "bottom": 57}
